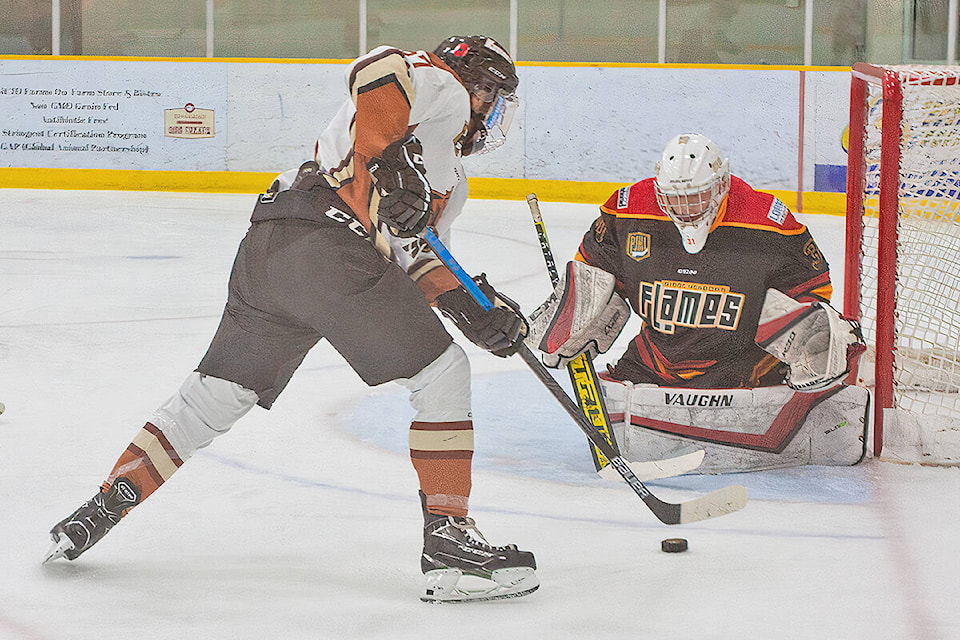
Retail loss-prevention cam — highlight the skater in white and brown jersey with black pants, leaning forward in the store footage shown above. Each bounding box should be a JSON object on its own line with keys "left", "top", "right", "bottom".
{"left": 47, "top": 36, "right": 539, "bottom": 601}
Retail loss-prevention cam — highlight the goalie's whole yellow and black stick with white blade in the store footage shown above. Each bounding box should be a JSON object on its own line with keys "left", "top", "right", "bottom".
{"left": 527, "top": 193, "right": 706, "bottom": 480}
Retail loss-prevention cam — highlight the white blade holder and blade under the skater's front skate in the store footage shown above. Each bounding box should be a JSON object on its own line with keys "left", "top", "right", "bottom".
{"left": 420, "top": 567, "right": 540, "bottom": 603}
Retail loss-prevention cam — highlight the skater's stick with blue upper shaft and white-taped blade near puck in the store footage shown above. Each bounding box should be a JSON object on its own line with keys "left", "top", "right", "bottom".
{"left": 420, "top": 227, "right": 747, "bottom": 524}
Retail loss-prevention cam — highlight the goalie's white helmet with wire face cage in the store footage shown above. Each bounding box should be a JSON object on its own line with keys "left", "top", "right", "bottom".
{"left": 653, "top": 133, "right": 730, "bottom": 253}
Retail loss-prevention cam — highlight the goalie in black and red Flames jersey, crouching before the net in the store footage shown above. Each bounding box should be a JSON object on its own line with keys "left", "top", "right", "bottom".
{"left": 527, "top": 134, "right": 869, "bottom": 473}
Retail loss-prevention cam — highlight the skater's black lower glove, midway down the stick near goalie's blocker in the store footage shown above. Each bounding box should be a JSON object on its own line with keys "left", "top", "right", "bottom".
{"left": 436, "top": 273, "right": 527, "bottom": 358}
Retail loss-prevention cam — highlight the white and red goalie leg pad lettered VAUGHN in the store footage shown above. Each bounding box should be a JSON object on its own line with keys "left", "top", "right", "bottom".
{"left": 603, "top": 380, "right": 869, "bottom": 473}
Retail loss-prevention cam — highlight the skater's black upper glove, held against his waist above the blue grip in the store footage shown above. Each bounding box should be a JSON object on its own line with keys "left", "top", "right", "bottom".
{"left": 367, "top": 135, "right": 430, "bottom": 238}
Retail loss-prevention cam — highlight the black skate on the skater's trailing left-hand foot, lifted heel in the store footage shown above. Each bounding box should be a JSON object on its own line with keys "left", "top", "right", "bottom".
{"left": 43, "top": 478, "right": 140, "bottom": 564}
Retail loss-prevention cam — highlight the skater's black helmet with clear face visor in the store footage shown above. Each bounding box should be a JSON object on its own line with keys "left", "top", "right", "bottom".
{"left": 434, "top": 36, "right": 520, "bottom": 156}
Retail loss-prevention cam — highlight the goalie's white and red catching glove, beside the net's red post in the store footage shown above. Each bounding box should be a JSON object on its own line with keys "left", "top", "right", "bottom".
{"left": 756, "top": 289, "right": 865, "bottom": 391}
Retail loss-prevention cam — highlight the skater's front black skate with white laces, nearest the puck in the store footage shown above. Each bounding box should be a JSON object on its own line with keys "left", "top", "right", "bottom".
{"left": 420, "top": 496, "right": 540, "bottom": 602}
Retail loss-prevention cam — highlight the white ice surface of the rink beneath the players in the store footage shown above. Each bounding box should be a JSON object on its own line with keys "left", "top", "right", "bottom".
{"left": 0, "top": 189, "right": 960, "bottom": 640}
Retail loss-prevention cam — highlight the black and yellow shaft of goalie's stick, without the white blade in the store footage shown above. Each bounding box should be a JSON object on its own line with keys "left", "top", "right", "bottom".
{"left": 527, "top": 193, "right": 620, "bottom": 472}
